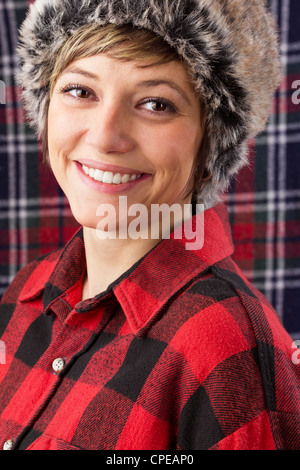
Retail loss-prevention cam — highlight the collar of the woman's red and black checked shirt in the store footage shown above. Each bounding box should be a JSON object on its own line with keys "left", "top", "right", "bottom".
{"left": 20, "top": 204, "right": 233, "bottom": 334}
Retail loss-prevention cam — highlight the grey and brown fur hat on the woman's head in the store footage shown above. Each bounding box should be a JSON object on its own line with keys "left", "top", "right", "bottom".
{"left": 17, "top": 0, "right": 281, "bottom": 207}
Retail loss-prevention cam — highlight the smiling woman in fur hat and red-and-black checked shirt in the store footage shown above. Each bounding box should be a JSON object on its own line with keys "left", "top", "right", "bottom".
{"left": 0, "top": 0, "right": 300, "bottom": 450}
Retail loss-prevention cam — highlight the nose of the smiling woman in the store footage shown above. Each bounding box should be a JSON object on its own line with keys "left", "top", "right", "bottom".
{"left": 86, "top": 104, "right": 135, "bottom": 154}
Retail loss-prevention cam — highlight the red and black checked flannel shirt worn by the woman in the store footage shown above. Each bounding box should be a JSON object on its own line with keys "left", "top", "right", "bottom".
{"left": 0, "top": 204, "right": 300, "bottom": 450}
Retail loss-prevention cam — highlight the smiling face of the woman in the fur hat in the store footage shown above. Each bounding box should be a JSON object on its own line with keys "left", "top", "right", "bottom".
{"left": 48, "top": 54, "right": 202, "bottom": 234}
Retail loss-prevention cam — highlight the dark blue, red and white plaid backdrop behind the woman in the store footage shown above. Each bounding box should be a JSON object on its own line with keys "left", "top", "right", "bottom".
{"left": 0, "top": 0, "right": 300, "bottom": 339}
